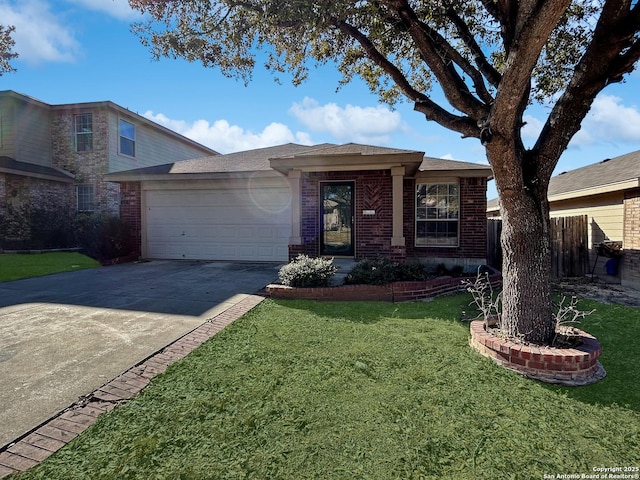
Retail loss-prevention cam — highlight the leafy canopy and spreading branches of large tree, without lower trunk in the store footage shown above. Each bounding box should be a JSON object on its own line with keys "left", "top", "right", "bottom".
{"left": 130, "top": 0, "right": 640, "bottom": 152}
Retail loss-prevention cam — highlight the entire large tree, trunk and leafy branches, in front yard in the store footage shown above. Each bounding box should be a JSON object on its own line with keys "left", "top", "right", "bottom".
{"left": 130, "top": 0, "right": 640, "bottom": 343}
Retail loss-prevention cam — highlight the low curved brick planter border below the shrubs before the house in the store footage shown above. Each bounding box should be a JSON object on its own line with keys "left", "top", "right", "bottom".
{"left": 266, "top": 273, "right": 502, "bottom": 302}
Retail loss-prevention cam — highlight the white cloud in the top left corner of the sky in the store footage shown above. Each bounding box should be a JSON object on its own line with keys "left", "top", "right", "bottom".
{"left": 0, "top": 0, "right": 80, "bottom": 65}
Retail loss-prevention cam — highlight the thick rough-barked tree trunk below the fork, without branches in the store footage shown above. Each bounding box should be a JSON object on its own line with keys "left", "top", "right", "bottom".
{"left": 487, "top": 145, "right": 555, "bottom": 345}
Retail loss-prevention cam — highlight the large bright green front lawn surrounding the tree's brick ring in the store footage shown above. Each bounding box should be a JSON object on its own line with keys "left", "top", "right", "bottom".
{"left": 18, "top": 295, "right": 640, "bottom": 480}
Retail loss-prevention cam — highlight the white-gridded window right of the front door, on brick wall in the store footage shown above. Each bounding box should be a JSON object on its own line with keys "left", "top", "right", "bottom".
{"left": 416, "top": 183, "right": 460, "bottom": 247}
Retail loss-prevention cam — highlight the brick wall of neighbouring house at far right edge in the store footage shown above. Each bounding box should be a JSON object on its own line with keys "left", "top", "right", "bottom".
{"left": 622, "top": 189, "right": 640, "bottom": 288}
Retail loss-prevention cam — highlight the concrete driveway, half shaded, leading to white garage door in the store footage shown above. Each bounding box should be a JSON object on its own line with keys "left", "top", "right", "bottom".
{"left": 0, "top": 261, "right": 278, "bottom": 447}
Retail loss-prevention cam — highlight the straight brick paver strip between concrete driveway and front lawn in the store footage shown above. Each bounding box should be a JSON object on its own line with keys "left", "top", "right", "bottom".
{"left": 0, "top": 295, "right": 264, "bottom": 478}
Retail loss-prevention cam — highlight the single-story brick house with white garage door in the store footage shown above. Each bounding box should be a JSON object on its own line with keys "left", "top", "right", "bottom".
{"left": 106, "top": 144, "right": 492, "bottom": 269}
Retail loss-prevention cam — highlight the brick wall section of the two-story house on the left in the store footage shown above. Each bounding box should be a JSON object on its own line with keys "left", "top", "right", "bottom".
{"left": 51, "top": 110, "right": 120, "bottom": 215}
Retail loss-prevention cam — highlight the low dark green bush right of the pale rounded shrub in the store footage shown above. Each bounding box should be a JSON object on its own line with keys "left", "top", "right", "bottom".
{"left": 344, "top": 257, "right": 429, "bottom": 285}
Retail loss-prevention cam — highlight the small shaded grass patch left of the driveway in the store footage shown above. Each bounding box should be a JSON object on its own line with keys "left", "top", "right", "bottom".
{"left": 0, "top": 252, "right": 100, "bottom": 282}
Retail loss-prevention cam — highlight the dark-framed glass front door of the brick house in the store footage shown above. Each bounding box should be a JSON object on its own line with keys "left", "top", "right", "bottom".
{"left": 320, "top": 182, "right": 354, "bottom": 257}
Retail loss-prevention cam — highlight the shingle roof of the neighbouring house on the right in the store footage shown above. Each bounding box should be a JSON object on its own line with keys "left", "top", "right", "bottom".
{"left": 549, "top": 150, "right": 640, "bottom": 197}
